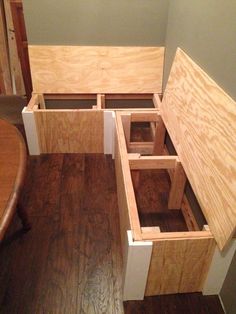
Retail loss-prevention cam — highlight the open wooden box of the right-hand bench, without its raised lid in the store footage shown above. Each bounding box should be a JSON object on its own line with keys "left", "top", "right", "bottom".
{"left": 115, "top": 112, "right": 215, "bottom": 296}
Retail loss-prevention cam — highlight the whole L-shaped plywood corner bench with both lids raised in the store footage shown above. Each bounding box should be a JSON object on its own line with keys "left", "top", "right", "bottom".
{"left": 23, "top": 46, "right": 236, "bottom": 300}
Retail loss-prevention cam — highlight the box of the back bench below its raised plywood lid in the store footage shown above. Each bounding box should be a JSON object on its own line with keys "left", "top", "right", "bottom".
{"left": 23, "top": 93, "right": 160, "bottom": 155}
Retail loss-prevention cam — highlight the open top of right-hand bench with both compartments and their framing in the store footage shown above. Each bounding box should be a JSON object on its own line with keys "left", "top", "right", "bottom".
{"left": 117, "top": 111, "right": 209, "bottom": 239}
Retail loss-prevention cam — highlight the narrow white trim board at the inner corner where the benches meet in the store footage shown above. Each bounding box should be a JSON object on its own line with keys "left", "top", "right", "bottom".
{"left": 104, "top": 111, "right": 115, "bottom": 156}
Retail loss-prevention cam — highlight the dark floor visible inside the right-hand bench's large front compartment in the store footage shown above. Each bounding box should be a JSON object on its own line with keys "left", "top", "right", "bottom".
{"left": 131, "top": 169, "right": 188, "bottom": 232}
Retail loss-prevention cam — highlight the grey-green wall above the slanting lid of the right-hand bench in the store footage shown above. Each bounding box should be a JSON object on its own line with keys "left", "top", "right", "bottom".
{"left": 164, "top": 0, "right": 236, "bottom": 99}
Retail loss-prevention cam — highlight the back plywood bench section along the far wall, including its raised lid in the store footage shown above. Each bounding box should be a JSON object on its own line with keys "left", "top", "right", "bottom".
{"left": 23, "top": 46, "right": 164, "bottom": 154}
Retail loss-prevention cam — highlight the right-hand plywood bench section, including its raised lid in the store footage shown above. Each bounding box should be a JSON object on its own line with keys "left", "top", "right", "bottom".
{"left": 115, "top": 49, "right": 236, "bottom": 300}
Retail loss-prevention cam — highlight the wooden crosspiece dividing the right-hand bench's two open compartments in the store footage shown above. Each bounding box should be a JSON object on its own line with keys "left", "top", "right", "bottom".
{"left": 128, "top": 154, "right": 178, "bottom": 170}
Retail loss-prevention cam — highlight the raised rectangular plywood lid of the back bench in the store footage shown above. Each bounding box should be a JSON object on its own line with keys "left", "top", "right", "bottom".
{"left": 29, "top": 46, "right": 164, "bottom": 93}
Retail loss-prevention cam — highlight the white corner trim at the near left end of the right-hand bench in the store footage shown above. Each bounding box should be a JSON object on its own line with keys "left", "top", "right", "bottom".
{"left": 123, "top": 230, "right": 152, "bottom": 301}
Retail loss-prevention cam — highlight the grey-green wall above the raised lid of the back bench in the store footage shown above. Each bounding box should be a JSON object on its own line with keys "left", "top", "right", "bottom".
{"left": 23, "top": 0, "right": 169, "bottom": 46}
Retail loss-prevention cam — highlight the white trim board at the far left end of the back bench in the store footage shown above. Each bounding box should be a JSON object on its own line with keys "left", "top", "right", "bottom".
{"left": 22, "top": 107, "right": 40, "bottom": 155}
